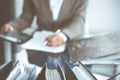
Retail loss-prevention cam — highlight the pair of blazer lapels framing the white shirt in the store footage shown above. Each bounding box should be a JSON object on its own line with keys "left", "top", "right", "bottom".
{"left": 41, "top": 0, "right": 75, "bottom": 22}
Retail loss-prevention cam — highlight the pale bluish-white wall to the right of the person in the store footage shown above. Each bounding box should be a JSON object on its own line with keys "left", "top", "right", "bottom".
{"left": 86, "top": 0, "right": 120, "bottom": 33}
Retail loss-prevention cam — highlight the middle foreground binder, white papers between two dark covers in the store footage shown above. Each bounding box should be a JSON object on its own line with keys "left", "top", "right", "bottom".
{"left": 36, "top": 64, "right": 66, "bottom": 80}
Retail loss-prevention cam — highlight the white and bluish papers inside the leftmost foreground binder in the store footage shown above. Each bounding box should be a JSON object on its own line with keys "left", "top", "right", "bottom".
{"left": 6, "top": 62, "right": 36, "bottom": 80}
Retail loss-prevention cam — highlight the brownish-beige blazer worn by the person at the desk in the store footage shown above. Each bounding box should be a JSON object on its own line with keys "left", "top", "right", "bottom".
{"left": 10, "top": 0, "right": 88, "bottom": 39}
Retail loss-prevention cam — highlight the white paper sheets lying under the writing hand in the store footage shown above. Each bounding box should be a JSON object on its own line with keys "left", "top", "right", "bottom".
{"left": 21, "top": 30, "right": 66, "bottom": 53}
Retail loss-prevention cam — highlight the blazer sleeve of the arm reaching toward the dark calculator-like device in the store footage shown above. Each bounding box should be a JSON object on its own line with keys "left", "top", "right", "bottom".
{"left": 8, "top": 0, "right": 34, "bottom": 31}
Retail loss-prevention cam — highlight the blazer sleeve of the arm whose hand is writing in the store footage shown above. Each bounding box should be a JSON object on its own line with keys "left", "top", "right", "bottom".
{"left": 62, "top": 0, "right": 88, "bottom": 40}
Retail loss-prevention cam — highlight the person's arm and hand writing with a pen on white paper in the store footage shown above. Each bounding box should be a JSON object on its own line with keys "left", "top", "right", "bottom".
{"left": 46, "top": 0, "right": 88, "bottom": 46}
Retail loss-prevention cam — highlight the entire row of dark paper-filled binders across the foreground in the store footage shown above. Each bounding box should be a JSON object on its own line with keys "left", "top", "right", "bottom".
{"left": 0, "top": 62, "right": 116, "bottom": 80}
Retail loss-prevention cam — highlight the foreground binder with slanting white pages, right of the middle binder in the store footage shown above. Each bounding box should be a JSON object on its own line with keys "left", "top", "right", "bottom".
{"left": 65, "top": 62, "right": 97, "bottom": 80}
